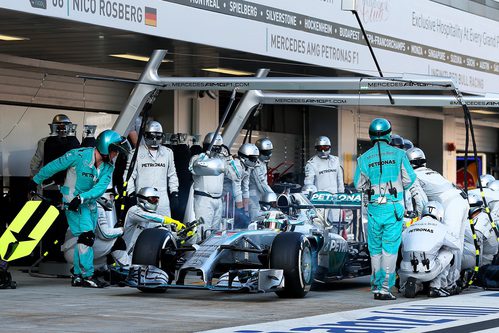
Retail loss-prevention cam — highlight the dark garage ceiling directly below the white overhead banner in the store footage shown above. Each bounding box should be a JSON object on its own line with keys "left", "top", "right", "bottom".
{"left": 0, "top": 9, "right": 346, "bottom": 76}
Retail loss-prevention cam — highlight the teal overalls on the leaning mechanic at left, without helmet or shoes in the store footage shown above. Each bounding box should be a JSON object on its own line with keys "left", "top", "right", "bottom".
{"left": 33, "top": 148, "right": 114, "bottom": 278}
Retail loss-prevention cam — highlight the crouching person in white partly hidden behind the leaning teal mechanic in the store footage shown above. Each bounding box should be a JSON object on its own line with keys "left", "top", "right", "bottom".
{"left": 61, "top": 190, "right": 130, "bottom": 272}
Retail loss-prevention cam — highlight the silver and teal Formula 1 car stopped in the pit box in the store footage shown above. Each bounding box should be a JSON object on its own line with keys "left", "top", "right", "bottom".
{"left": 127, "top": 192, "right": 371, "bottom": 298}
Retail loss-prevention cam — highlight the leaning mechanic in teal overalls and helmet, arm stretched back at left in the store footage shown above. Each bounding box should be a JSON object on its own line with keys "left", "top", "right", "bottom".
{"left": 30, "top": 130, "right": 130, "bottom": 288}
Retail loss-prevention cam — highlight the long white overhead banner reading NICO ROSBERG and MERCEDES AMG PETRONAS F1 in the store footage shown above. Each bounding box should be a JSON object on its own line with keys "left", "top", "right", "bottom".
{"left": 0, "top": 0, "right": 499, "bottom": 93}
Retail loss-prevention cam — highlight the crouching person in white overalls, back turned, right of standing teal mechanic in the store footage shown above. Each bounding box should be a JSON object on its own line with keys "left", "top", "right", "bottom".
{"left": 398, "top": 201, "right": 457, "bottom": 298}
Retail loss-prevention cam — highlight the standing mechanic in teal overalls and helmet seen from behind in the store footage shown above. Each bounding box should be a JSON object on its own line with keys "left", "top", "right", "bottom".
{"left": 354, "top": 118, "right": 416, "bottom": 300}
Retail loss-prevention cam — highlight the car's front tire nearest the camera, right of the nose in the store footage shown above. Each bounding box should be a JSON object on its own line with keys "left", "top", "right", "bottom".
{"left": 270, "top": 232, "right": 314, "bottom": 298}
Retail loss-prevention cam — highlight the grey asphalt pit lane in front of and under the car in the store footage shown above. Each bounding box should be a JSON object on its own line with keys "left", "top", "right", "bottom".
{"left": 0, "top": 270, "right": 492, "bottom": 333}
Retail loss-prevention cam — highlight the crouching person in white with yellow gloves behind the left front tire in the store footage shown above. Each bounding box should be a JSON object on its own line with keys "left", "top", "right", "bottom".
{"left": 123, "top": 187, "right": 185, "bottom": 257}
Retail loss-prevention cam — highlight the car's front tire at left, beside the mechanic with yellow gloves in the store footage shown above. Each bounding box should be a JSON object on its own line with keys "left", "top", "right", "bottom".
{"left": 132, "top": 228, "right": 170, "bottom": 294}
